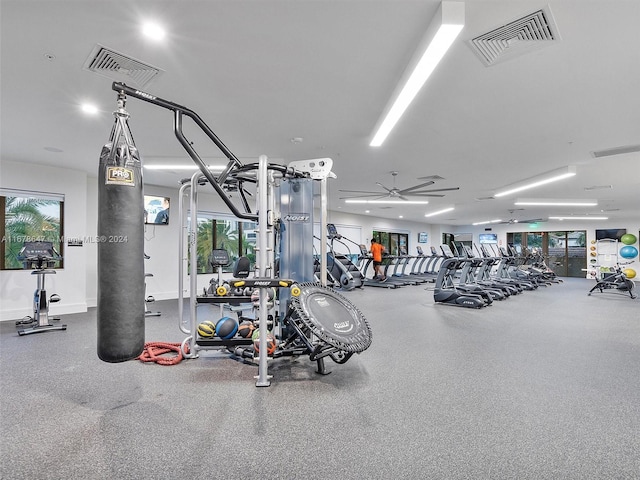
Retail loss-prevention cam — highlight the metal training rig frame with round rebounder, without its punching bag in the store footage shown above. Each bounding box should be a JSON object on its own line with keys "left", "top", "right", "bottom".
{"left": 112, "top": 82, "right": 372, "bottom": 387}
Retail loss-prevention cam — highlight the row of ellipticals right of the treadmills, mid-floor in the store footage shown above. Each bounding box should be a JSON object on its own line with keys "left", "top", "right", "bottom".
{"left": 432, "top": 242, "right": 562, "bottom": 308}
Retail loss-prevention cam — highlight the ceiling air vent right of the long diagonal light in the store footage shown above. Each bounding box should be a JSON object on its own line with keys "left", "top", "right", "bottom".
{"left": 469, "top": 6, "right": 560, "bottom": 67}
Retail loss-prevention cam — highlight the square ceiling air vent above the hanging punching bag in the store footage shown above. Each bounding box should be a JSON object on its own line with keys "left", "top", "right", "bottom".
{"left": 84, "top": 45, "right": 162, "bottom": 88}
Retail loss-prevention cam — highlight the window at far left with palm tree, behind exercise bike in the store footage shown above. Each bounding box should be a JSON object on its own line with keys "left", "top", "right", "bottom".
{"left": 0, "top": 189, "right": 64, "bottom": 270}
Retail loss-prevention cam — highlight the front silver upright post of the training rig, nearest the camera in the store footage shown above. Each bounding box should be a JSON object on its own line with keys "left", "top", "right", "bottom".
{"left": 256, "top": 155, "right": 271, "bottom": 387}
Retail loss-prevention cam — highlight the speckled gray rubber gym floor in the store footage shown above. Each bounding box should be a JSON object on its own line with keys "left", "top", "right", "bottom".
{"left": 0, "top": 279, "right": 640, "bottom": 479}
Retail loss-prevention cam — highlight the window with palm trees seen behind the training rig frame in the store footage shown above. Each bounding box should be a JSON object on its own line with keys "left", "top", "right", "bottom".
{"left": 190, "top": 212, "right": 256, "bottom": 273}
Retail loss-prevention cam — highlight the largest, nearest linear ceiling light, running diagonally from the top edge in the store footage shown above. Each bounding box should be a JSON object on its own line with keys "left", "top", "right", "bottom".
{"left": 369, "top": 1, "right": 464, "bottom": 147}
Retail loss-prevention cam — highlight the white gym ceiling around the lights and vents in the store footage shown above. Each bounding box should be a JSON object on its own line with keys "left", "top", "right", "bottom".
{"left": 0, "top": 0, "right": 640, "bottom": 225}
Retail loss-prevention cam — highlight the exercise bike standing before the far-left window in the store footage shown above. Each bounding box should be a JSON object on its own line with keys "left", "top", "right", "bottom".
{"left": 16, "top": 242, "right": 67, "bottom": 335}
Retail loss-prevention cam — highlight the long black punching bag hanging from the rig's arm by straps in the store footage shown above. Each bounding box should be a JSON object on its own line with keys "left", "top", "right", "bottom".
{"left": 97, "top": 95, "right": 145, "bottom": 363}
